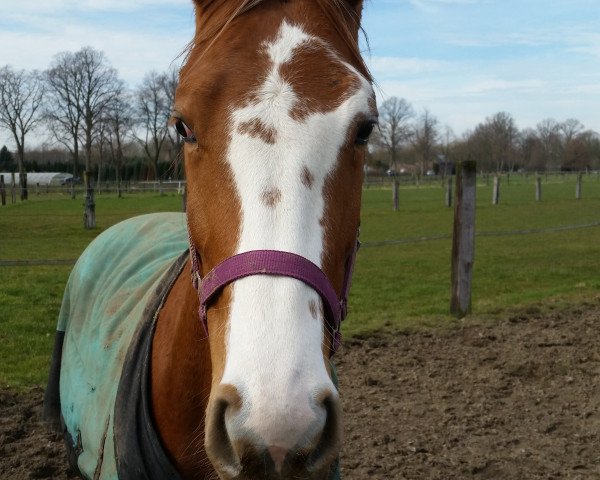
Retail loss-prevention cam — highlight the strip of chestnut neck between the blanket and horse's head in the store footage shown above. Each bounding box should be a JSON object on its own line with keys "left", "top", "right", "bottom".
{"left": 151, "top": 262, "right": 211, "bottom": 478}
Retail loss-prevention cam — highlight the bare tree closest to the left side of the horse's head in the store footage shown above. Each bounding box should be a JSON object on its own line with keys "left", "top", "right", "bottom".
{"left": 135, "top": 71, "right": 171, "bottom": 193}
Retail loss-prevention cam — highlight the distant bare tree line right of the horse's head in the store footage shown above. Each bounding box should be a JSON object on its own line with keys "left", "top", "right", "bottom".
{"left": 368, "top": 97, "right": 600, "bottom": 175}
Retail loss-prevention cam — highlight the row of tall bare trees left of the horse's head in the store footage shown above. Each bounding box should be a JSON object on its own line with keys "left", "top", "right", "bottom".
{"left": 0, "top": 47, "right": 181, "bottom": 198}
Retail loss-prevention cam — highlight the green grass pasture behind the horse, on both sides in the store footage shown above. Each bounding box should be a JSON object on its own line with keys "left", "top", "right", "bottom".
{"left": 0, "top": 176, "right": 600, "bottom": 387}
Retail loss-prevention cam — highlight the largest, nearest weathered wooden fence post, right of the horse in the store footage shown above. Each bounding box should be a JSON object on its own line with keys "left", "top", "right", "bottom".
{"left": 450, "top": 160, "right": 477, "bottom": 318}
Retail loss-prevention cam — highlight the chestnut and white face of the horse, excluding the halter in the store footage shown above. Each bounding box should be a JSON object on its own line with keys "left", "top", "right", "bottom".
{"left": 174, "top": 0, "right": 376, "bottom": 479}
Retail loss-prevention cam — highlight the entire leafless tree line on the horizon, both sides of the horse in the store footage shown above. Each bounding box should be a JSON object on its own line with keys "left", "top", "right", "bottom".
{"left": 0, "top": 47, "right": 600, "bottom": 199}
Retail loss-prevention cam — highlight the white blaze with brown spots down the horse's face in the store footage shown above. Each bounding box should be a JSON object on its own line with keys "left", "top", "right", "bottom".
{"left": 222, "top": 22, "right": 372, "bottom": 448}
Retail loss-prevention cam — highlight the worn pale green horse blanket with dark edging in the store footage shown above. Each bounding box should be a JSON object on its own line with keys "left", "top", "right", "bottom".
{"left": 45, "top": 213, "right": 188, "bottom": 480}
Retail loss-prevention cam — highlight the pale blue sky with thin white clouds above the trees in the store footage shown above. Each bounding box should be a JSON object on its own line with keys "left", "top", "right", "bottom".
{"left": 0, "top": 0, "right": 600, "bottom": 148}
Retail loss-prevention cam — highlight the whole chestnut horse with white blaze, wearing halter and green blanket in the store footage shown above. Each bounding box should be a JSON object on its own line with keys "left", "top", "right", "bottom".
{"left": 45, "top": 0, "right": 377, "bottom": 480}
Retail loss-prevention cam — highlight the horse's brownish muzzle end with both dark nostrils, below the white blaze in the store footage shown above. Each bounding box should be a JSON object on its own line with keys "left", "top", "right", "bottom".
{"left": 205, "top": 385, "right": 341, "bottom": 480}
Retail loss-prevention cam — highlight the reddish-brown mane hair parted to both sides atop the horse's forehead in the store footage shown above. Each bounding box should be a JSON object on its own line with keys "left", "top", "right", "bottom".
{"left": 184, "top": 0, "right": 373, "bottom": 82}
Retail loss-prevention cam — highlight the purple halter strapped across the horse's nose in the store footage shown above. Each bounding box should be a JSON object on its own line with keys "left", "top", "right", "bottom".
{"left": 190, "top": 235, "right": 360, "bottom": 354}
